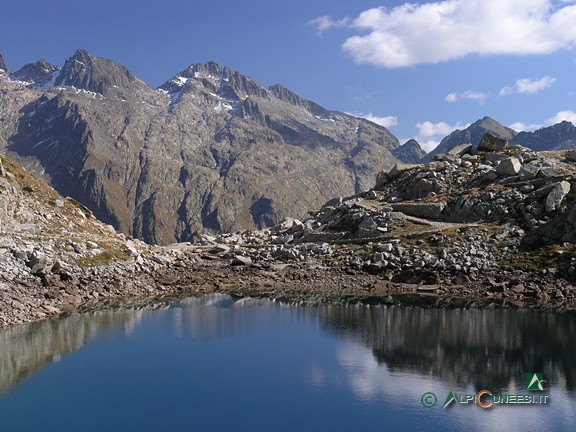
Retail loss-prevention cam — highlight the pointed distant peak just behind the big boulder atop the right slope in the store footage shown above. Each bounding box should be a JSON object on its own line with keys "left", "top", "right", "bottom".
{"left": 422, "top": 116, "right": 517, "bottom": 163}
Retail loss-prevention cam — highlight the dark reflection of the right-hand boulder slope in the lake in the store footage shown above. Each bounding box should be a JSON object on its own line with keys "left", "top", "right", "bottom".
{"left": 319, "top": 307, "right": 576, "bottom": 392}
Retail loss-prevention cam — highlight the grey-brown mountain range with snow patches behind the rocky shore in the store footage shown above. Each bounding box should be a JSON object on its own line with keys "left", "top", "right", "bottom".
{"left": 0, "top": 50, "right": 576, "bottom": 244}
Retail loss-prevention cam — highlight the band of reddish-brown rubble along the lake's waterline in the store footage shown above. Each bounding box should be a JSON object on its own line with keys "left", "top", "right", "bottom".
{"left": 0, "top": 248, "right": 576, "bottom": 328}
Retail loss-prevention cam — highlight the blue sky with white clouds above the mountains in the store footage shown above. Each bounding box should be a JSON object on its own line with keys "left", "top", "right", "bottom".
{"left": 0, "top": 0, "right": 576, "bottom": 150}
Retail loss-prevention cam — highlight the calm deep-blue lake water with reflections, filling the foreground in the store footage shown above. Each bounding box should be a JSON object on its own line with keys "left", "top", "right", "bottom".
{"left": 0, "top": 295, "right": 576, "bottom": 432}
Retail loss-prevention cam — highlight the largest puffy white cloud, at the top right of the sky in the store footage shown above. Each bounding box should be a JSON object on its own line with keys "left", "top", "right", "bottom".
{"left": 311, "top": 0, "right": 576, "bottom": 68}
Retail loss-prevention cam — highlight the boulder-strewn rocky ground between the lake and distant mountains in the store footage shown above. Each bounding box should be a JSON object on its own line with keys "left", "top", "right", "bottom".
{"left": 0, "top": 137, "right": 576, "bottom": 328}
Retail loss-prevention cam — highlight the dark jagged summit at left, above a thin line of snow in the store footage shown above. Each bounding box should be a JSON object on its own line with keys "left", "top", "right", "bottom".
{"left": 55, "top": 49, "right": 136, "bottom": 95}
